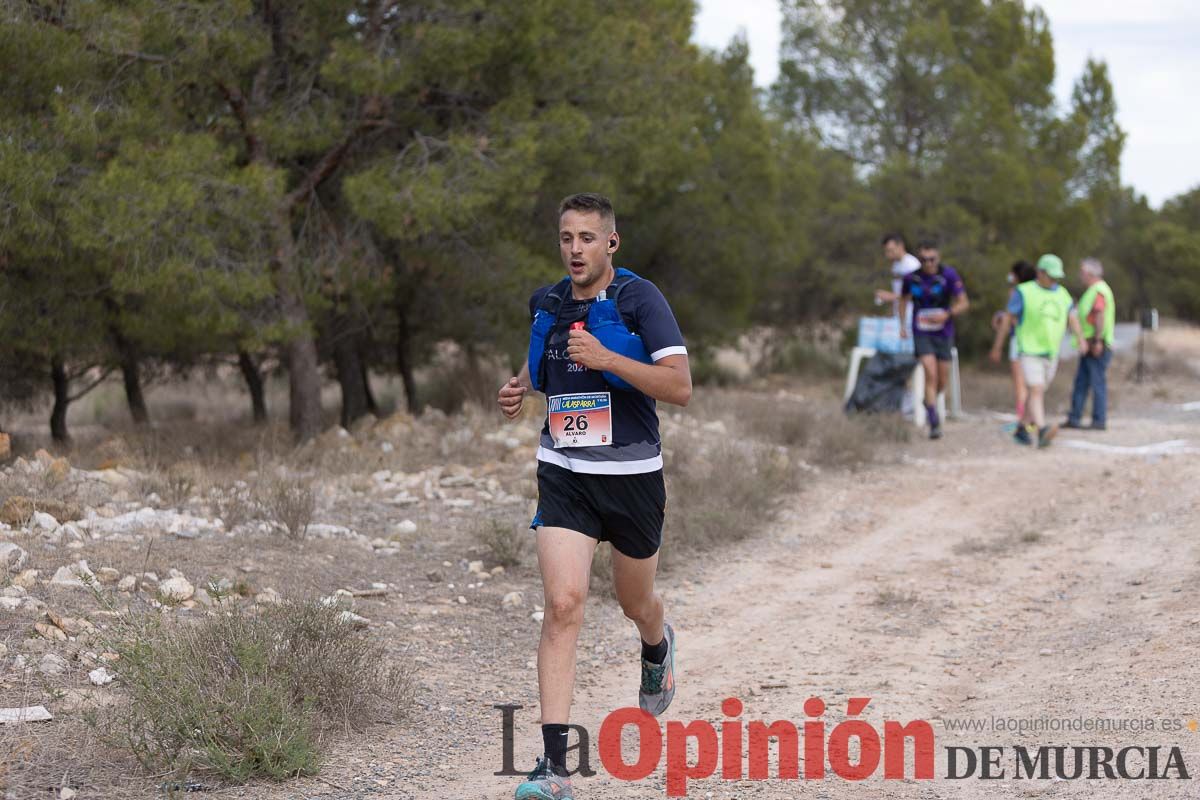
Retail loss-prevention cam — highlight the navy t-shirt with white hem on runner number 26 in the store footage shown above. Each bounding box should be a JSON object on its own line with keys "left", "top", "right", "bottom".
{"left": 529, "top": 278, "right": 688, "bottom": 475}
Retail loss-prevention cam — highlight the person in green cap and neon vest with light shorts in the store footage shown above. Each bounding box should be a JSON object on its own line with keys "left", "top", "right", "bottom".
{"left": 990, "top": 253, "right": 1085, "bottom": 447}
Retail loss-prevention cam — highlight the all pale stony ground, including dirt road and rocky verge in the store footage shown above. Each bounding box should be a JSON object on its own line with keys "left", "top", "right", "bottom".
{"left": 0, "top": 326, "right": 1200, "bottom": 800}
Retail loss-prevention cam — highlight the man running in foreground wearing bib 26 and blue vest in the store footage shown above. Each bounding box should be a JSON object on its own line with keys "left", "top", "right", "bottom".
{"left": 499, "top": 193, "right": 691, "bottom": 800}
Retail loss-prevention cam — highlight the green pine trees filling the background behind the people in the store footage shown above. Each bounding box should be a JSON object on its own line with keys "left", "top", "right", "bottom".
{"left": 0, "top": 0, "right": 1200, "bottom": 439}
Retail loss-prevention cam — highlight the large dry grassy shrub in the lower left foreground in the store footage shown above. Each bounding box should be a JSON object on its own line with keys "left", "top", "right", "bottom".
{"left": 91, "top": 602, "right": 413, "bottom": 782}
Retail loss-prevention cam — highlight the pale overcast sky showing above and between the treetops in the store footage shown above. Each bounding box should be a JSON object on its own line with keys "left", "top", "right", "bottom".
{"left": 696, "top": 0, "right": 1200, "bottom": 206}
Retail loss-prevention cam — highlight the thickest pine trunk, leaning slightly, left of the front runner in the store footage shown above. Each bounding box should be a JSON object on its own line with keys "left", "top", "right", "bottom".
{"left": 272, "top": 207, "right": 320, "bottom": 441}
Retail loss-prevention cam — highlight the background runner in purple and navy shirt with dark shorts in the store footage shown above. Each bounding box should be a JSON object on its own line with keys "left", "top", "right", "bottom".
{"left": 900, "top": 240, "right": 971, "bottom": 439}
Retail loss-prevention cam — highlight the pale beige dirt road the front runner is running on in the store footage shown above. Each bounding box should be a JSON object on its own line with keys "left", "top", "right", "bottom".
{"left": 236, "top": 362, "right": 1200, "bottom": 800}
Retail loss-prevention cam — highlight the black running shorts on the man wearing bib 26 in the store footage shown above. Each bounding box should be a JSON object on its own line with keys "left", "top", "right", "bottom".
{"left": 529, "top": 462, "right": 667, "bottom": 559}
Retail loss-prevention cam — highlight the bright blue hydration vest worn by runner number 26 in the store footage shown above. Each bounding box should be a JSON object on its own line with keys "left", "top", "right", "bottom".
{"left": 529, "top": 269, "right": 654, "bottom": 392}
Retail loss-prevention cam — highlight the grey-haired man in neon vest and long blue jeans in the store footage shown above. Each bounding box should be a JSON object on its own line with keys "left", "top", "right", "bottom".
{"left": 1063, "top": 258, "right": 1117, "bottom": 431}
